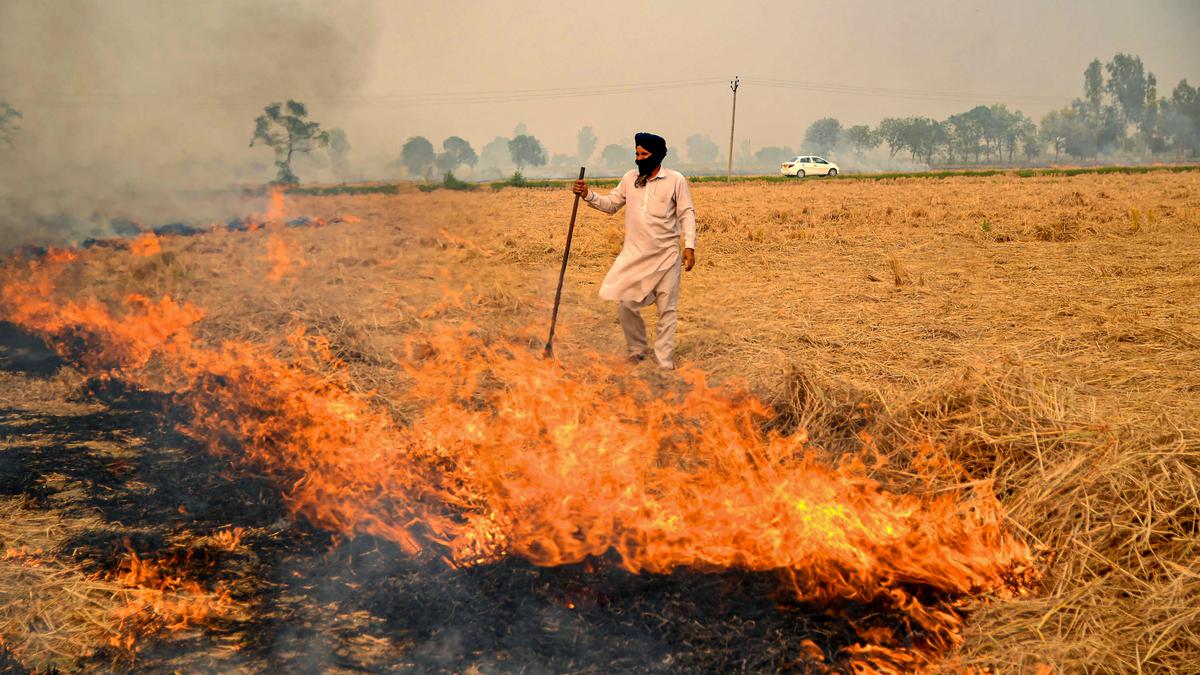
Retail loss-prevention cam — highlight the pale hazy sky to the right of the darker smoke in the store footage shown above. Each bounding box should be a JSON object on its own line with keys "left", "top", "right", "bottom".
{"left": 356, "top": 0, "right": 1200, "bottom": 150}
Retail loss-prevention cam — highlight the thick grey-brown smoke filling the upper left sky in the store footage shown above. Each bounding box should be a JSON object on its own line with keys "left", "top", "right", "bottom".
{"left": 0, "top": 0, "right": 377, "bottom": 250}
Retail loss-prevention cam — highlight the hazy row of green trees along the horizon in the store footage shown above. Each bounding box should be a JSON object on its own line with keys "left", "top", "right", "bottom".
{"left": 0, "top": 53, "right": 1200, "bottom": 184}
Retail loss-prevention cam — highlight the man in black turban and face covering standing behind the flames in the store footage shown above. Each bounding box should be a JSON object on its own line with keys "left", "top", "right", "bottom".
{"left": 572, "top": 132, "right": 696, "bottom": 369}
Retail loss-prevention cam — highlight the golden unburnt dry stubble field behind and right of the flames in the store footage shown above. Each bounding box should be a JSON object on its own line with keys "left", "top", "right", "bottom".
{"left": 0, "top": 166, "right": 1200, "bottom": 671}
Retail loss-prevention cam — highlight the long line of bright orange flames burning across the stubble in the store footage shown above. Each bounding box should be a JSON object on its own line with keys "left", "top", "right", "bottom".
{"left": 0, "top": 254, "right": 1030, "bottom": 651}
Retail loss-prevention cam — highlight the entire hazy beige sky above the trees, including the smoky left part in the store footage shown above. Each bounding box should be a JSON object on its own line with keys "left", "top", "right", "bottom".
{"left": 0, "top": 0, "right": 1200, "bottom": 180}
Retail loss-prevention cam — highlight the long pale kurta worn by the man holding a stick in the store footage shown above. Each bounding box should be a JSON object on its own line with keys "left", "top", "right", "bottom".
{"left": 584, "top": 167, "right": 696, "bottom": 301}
